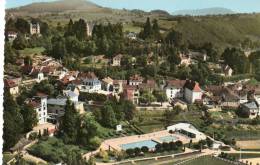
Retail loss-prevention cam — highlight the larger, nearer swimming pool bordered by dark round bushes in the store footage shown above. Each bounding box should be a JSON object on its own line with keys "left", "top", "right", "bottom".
{"left": 121, "top": 140, "right": 158, "bottom": 150}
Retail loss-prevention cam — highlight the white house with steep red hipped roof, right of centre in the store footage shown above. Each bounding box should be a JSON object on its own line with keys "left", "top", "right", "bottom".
{"left": 184, "top": 80, "right": 203, "bottom": 103}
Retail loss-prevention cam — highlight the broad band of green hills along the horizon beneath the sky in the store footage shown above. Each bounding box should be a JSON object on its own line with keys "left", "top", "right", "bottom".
{"left": 7, "top": 0, "right": 260, "bottom": 48}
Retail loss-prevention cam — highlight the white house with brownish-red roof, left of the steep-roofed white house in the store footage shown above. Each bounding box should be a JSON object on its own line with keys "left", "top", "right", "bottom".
{"left": 164, "top": 80, "right": 186, "bottom": 101}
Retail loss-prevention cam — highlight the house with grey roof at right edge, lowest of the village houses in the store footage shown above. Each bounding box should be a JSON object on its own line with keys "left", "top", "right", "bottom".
{"left": 241, "top": 101, "right": 260, "bottom": 119}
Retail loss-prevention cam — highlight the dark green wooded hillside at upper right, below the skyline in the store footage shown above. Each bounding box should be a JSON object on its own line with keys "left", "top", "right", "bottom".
{"left": 169, "top": 14, "right": 260, "bottom": 47}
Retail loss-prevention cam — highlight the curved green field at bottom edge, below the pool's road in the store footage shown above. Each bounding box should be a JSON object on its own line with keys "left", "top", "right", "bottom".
{"left": 183, "top": 156, "right": 232, "bottom": 165}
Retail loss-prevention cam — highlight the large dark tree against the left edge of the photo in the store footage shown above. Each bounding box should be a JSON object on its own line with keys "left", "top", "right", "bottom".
{"left": 3, "top": 90, "right": 23, "bottom": 151}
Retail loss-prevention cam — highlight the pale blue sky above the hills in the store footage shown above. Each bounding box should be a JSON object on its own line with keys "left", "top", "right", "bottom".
{"left": 5, "top": 0, "right": 260, "bottom": 13}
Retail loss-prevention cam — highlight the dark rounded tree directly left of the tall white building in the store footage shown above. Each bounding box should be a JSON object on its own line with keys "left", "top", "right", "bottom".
{"left": 21, "top": 105, "right": 38, "bottom": 132}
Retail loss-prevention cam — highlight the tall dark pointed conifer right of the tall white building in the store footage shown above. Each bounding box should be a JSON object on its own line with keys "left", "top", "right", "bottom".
{"left": 59, "top": 99, "right": 79, "bottom": 144}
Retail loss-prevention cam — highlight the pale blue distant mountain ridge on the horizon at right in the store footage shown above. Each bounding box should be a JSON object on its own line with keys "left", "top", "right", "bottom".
{"left": 172, "top": 7, "right": 235, "bottom": 16}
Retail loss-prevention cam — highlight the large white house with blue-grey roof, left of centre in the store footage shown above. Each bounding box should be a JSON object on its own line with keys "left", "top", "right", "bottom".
{"left": 79, "top": 72, "right": 101, "bottom": 93}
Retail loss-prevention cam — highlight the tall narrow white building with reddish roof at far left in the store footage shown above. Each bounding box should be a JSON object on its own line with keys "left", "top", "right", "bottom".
{"left": 25, "top": 94, "right": 48, "bottom": 124}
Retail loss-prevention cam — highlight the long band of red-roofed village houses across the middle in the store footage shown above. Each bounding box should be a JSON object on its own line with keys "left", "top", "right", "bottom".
{"left": 4, "top": 52, "right": 260, "bottom": 131}
